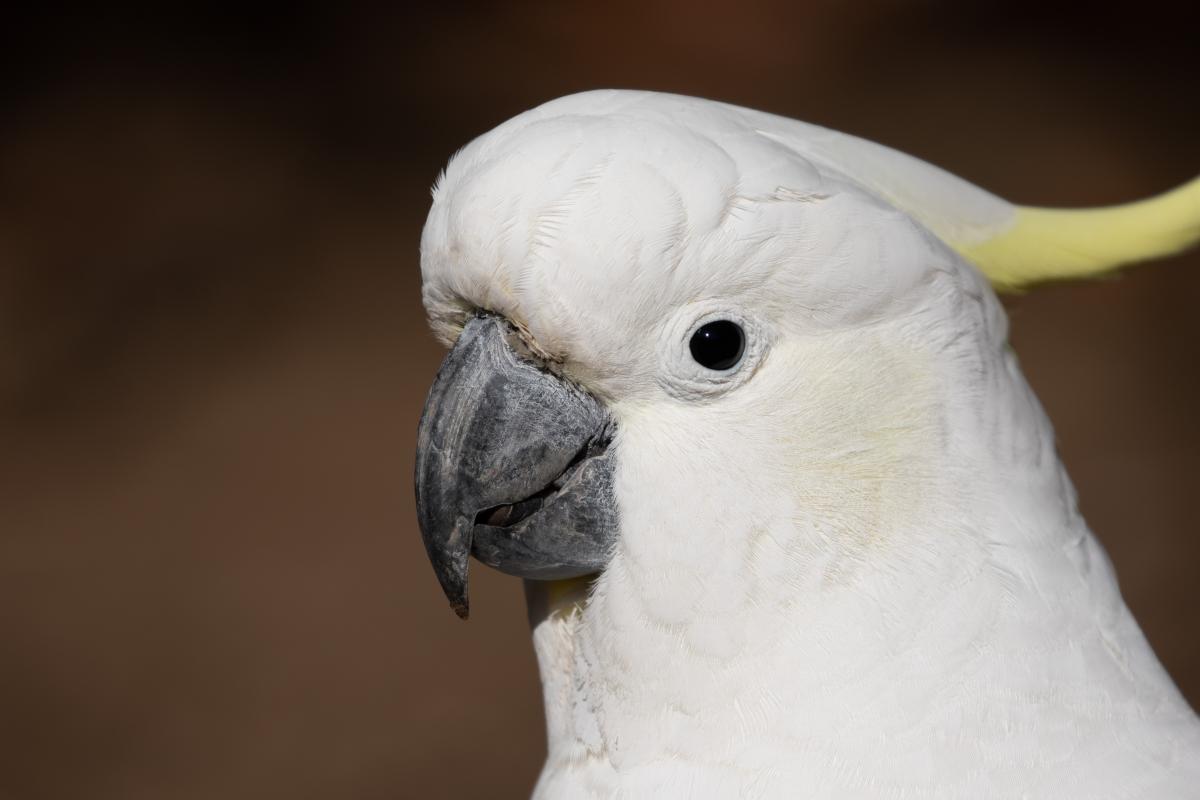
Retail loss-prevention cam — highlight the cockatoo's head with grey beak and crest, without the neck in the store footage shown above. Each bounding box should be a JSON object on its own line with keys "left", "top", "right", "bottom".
{"left": 416, "top": 91, "right": 1200, "bottom": 622}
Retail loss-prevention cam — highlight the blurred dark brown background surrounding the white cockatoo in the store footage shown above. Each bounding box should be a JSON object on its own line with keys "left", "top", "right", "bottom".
{"left": 0, "top": 0, "right": 1200, "bottom": 800}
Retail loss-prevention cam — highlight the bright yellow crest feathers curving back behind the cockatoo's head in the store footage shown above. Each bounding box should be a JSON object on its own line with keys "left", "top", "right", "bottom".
{"left": 950, "top": 178, "right": 1200, "bottom": 291}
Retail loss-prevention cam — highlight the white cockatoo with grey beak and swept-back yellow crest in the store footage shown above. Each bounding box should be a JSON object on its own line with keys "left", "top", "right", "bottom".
{"left": 416, "top": 91, "right": 1200, "bottom": 800}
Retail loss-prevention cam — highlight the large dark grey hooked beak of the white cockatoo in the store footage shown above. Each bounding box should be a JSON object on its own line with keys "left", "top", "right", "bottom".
{"left": 416, "top": 315, "right": 617, "bottom": 619}
